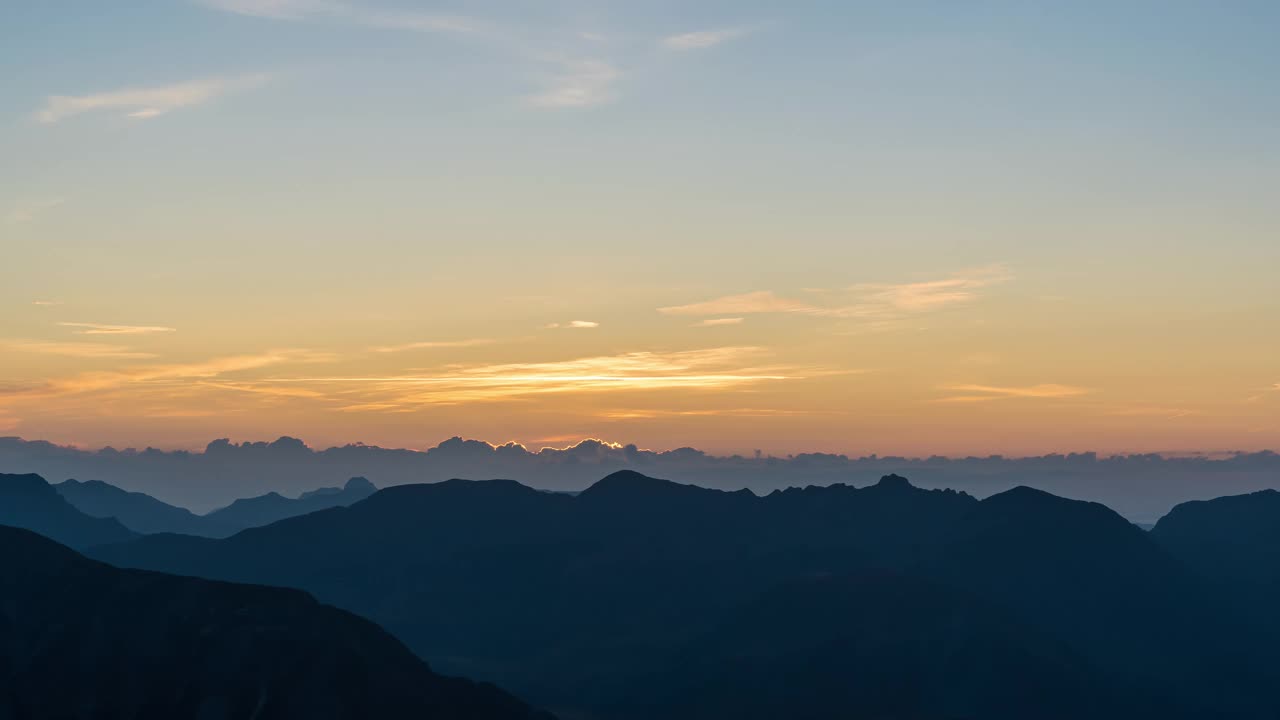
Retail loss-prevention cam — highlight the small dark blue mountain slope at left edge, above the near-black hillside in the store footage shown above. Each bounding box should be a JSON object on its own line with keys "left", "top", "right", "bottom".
{"left": 0, "top": 474, "right": 134, "bottom": 548}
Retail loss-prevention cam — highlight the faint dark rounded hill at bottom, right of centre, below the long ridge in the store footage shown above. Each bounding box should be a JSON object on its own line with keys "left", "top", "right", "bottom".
{"left": 627, "top": 571, "right": 1152, "bottom": 720}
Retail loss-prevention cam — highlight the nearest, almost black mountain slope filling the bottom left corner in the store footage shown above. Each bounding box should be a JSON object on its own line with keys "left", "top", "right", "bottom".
{"left": 0, "top": 520, "right": 550, "bottom": 720}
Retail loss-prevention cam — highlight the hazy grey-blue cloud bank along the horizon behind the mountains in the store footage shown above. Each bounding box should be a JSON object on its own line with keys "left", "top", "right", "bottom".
{"left": 0, "top": 437, "right": 1280, "bottom": 523}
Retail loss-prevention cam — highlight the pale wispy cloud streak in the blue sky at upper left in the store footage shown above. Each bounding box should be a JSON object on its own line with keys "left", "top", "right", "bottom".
{"left": 36, "top": 74, "right": 270, "bottom": 124}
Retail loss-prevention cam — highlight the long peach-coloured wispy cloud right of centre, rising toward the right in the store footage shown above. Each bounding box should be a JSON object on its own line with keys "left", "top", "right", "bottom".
{"left": 658, "top": 265, "right": 1012, "bottom": 320}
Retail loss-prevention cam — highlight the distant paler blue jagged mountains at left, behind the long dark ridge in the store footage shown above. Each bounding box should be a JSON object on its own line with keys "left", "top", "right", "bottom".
{"left": 54, "top": 478, "right": 378, "bottom": 538}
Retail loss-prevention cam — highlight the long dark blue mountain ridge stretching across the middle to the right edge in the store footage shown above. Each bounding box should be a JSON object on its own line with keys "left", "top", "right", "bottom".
{"left": 92, "top": 471, "right": 1280, "bottom": 720}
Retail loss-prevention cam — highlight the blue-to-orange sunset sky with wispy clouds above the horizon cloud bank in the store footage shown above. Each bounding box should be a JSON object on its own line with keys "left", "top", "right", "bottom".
{"left": 0, "top": 0, "right": 1280, "bottom": 455}
